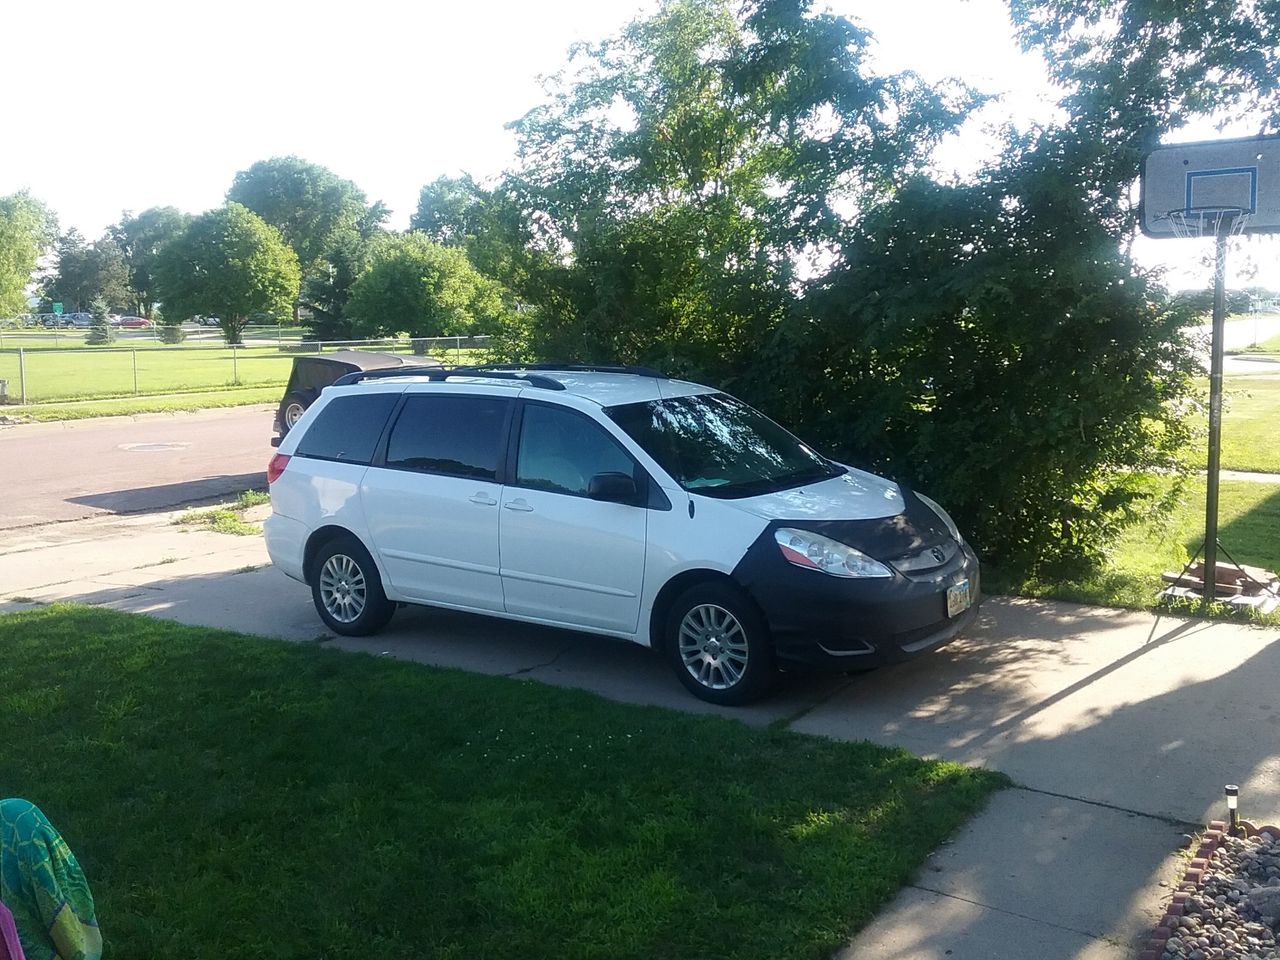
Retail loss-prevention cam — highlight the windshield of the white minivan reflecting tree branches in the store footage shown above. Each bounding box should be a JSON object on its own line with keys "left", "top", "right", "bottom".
{"left": 605, "top": 393, "right": 845, "bottom": 498}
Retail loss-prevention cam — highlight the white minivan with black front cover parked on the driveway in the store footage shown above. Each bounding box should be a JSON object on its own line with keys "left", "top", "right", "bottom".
{"left": 266, "top": 365, "right": 979, "bottom": 704}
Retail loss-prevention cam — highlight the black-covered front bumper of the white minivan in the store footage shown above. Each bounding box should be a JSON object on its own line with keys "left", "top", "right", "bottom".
{"left": 733, "top": 530, "right": 982, "bottom": 671}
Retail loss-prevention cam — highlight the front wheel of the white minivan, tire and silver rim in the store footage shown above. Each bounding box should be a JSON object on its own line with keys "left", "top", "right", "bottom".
{"left": 663, "top": 582, "right": 777, "bottom": 707}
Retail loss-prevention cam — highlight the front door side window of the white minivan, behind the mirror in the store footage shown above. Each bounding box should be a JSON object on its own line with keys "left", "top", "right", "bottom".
{"left": 516, "top": 403, "right": 639, "bottom": 497}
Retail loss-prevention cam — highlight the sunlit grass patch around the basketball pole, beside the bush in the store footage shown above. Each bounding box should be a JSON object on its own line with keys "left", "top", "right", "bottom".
{"left": 987, "top": 480, "right": 1280, "bottom": 623}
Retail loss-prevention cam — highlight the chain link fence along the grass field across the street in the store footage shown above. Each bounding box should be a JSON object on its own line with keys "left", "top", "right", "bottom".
{"left": 0, "top": 334, "right": 489, "bottom": 404}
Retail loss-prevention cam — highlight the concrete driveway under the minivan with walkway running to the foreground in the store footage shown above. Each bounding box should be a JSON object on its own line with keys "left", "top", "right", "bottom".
{"left": 0, "top": 513, "right": 1280, "bottom": 960}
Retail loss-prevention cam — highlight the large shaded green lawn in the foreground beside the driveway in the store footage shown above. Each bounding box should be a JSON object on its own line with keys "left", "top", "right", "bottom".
{"left": 0, "top": 607, "right": 1006, "bottom": 960}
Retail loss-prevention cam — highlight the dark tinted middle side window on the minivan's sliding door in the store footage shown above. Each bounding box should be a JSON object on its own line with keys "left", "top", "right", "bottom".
{"left": 387, "top": 394, "right": 511, "bottom": 480}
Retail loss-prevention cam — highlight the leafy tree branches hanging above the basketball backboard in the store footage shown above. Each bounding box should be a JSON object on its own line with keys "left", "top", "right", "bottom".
{"left": 1010, "top": 0, "right": 1280, "bottom": 237}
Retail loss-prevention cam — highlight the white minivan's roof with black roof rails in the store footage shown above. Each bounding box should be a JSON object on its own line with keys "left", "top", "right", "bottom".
{"left": 340, "top": 364, "right": 719, "bottom": 407}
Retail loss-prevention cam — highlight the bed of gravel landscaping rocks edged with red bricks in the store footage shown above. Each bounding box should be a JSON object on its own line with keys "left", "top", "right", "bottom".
{"left": 1164, "top": 833, "right": 1280, "bottom": 960}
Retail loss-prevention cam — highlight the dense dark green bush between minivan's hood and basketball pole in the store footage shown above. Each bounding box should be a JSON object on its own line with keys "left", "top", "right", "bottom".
{"left": 742, "top": 175, "right": 1194, "bottom": 573}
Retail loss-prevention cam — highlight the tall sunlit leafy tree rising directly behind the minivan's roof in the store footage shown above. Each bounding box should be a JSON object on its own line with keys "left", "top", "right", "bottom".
{"left": 504, "top": 0, "right": 975, "bottom": 372}
